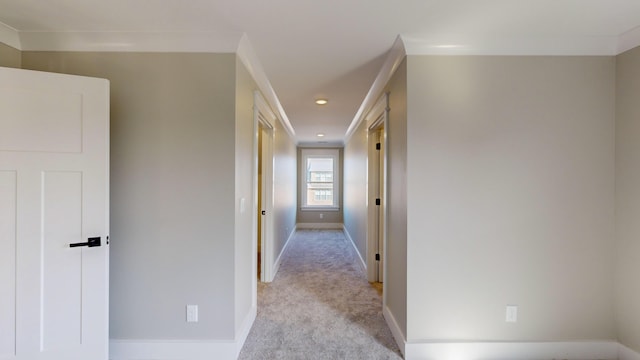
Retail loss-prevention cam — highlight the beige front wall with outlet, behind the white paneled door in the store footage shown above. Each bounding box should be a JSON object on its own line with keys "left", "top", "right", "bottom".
{"left": 23, "top": 52, "right": 240, "bottom": 339}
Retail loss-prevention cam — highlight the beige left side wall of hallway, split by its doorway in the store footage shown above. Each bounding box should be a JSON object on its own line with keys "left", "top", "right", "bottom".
{"left": 235, "top": 59, "right": 296, "bottom": 335}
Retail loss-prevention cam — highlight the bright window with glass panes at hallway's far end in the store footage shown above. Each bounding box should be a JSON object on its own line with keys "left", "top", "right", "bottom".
{"left": 301, "top": 149, "right": 340, "bottom": 210}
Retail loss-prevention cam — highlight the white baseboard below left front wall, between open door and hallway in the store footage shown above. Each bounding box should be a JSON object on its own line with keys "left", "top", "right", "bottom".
{"left": 109, "top": 339, "right": 237, "bottom": 360}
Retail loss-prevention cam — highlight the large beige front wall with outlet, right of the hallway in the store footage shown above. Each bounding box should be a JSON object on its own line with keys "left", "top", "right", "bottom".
{"left": 404, "top": 56, "right": 616, "bottom": 341}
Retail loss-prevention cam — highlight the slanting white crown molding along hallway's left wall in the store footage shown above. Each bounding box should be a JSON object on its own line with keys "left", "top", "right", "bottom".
{"left": 236, "top": 34, "right": 296, "bottom": 142}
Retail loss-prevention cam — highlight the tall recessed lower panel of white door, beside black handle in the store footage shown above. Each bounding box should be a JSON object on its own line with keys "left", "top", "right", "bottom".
{"left": 40, "top": 172, "right": 83, "bottom": 352}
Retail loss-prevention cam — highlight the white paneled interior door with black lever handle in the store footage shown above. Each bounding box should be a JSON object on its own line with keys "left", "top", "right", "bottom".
{"left": 0, "top": 68, "right": 109, "bottom": 360}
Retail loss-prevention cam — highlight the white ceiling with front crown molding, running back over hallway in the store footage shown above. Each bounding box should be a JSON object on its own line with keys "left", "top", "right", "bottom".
{"left": 0, "top": 0, "right": 640, "bottom": 143}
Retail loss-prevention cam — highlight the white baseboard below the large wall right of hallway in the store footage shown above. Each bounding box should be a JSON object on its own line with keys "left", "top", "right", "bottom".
{"left": 404, "top": 341, "right": 618, "bottom": 360}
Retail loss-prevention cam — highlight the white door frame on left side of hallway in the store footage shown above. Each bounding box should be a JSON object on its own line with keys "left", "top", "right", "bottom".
{"left": 253, "top": 91, "right": 277, "bottom": 289}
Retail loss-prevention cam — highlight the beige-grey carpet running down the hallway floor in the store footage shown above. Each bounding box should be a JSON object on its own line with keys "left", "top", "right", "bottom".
{"left": 239, "top": 230, "right": 402, "bottom": 360}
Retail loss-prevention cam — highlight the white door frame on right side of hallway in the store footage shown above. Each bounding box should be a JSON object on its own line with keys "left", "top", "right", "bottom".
{"left": 365, "top": 93, "right": 389, "bottom": 284}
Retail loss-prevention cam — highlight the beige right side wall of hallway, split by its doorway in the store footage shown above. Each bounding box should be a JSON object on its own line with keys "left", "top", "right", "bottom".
{"left": 344, "top": 57, "right": 407, "bottom": 335}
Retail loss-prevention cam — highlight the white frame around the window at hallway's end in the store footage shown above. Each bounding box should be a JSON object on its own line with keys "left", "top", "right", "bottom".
{"left": 300, "top": 148, "right": 340, "bottom": 211}
